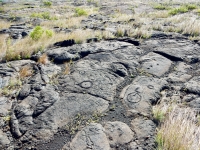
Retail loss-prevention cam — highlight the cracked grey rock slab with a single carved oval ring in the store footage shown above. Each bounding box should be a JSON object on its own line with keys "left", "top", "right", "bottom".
{"left": 59, "top": 70, "right": 123, "bottom": 100}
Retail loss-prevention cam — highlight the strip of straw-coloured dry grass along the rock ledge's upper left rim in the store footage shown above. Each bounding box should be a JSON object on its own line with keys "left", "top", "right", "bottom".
{"left": 6, "top": 30, "right": 103, "bottom": 61}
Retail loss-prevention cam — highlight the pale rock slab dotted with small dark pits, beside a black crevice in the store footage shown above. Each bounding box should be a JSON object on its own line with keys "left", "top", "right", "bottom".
{"left": 140, "top": 52, "right": 172, "bottom": 77}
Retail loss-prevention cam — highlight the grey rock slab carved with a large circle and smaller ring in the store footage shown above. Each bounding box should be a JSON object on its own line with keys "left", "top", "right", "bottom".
{"left": 120, "top": 76, "right": 167, "bottom": 116}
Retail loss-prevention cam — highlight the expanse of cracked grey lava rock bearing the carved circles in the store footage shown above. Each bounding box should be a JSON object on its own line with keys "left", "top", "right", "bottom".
{"left": 0, "top": 33, "right": 200, "bottom": 150}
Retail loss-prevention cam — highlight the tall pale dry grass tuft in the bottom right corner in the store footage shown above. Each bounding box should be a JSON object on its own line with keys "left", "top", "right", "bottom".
{"left": 156, "top": 106, "right": 200, "bottom": 150}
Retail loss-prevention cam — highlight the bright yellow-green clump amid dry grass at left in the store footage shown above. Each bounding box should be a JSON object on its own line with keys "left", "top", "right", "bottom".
{"left": 30, "top": 26, "right": 53, "bottom": 41}
